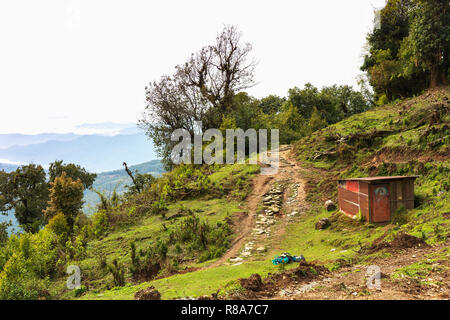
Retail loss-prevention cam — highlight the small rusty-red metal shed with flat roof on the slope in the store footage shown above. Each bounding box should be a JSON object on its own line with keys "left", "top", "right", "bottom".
{"left": 338, "top": 176, "right": 418, "bottom": 222}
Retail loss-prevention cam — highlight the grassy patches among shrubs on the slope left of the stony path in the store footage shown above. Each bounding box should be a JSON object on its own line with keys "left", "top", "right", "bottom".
{"left": 52, "top": 165, "right": 259, "bottom": 298}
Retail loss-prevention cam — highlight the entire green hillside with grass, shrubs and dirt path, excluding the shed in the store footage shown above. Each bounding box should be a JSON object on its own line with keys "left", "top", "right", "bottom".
{"left": 0, "top": 87, "right": 450, "bottom": 299}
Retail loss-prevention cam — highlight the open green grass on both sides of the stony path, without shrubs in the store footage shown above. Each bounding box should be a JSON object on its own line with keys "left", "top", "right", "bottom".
{"left": 62, "top": 87, "right": 450, "bottom": 299}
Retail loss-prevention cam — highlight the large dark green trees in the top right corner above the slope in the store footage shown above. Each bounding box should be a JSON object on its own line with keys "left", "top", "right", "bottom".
{"left": 361, "top": 0, "right": 450, "bottom": 100}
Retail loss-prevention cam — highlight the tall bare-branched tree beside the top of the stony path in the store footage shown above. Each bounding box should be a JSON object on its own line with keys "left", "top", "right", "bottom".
{"left": 139, "top": 26, "right": 256, "bottom": 165}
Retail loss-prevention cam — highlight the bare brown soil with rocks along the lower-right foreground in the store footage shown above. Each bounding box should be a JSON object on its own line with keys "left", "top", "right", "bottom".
{"left": 223, "top": 240, "right": 450, "bottom": 300}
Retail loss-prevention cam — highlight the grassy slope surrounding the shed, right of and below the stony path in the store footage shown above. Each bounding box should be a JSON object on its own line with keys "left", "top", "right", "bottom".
{"left": 77, "top": 88, "right": 450, "bottom": 299}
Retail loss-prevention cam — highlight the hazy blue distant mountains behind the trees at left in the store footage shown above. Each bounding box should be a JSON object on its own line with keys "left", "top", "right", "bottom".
{"left": 0, "top": 122, "right": 164, "bottom": 231}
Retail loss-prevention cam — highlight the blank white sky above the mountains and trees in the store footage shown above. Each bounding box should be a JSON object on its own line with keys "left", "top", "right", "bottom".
{"left": 0, "top": 0, "right": 385, "bottom": 133}
